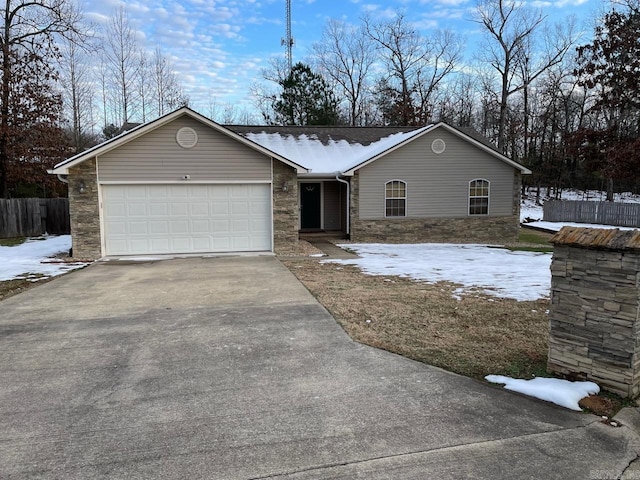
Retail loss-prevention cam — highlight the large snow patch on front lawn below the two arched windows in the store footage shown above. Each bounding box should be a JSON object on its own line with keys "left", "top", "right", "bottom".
{"left": 325, "top": 243, "right": 551, "bottom": 301}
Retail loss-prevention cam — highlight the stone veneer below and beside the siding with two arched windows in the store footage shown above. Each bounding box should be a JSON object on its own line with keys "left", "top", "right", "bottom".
{"left": 350, "top": 172, "right": 520, "bottom": 243}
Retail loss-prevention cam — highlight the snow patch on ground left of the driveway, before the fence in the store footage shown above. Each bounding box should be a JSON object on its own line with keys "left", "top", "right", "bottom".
{"left": 0, "top": 235, "right": 86, "bottom": 282}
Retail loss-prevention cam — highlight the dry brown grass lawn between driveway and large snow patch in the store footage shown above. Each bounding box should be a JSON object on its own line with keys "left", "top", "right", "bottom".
{"left": 282, "top": 259, "right": 549, "bottom": 379}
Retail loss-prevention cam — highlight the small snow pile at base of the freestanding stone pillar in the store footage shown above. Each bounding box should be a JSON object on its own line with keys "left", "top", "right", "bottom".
{"left": 484, "top": 375, "right": 600, "bottom": 411}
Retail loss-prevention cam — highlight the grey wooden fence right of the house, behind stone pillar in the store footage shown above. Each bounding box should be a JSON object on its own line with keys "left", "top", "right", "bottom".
{"left": 543, "top": 200, "right": 640, "bottom": 227}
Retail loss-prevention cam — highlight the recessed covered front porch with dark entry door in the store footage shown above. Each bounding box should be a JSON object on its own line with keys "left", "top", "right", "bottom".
{"left": 298, "top": 178, "right": 349, "bottom": 238}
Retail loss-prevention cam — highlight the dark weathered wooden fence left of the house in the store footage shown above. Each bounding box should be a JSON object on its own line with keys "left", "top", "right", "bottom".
{"left": 0, "top": 198, "right": 71, "bottom": 238}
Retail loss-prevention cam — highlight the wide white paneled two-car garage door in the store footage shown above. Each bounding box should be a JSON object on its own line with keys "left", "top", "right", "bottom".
{"left": 102, "top": 184, "right": 271, "bottom": 255}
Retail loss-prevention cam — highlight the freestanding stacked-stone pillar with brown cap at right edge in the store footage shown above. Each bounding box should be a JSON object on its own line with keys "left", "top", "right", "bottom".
{"left": 547, "top": 227, "right": 640, "bottom": 397}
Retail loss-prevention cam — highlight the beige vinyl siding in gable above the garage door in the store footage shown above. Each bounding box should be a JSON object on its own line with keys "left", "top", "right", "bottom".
{"left": 98, "top": 116, "right": 271, "bottom": 182}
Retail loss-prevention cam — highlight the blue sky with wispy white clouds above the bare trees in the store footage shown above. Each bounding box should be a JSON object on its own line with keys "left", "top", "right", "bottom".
{"left": 80, "top": 0, "right": 605, "bottom": 121}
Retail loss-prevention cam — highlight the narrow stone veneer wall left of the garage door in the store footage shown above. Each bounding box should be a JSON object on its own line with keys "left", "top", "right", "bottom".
{"left": 68, "top": 159, "right": 102, "bottom": 260}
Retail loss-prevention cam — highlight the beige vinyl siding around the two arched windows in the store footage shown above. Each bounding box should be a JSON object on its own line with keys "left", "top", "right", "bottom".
{"left": 359, "top": 128, "right": 514, "bottom": 220}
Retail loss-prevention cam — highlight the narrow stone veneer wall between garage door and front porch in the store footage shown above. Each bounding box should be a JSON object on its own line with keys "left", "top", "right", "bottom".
{"left": 273, "top": 160, "right": 300, "bottom": 254}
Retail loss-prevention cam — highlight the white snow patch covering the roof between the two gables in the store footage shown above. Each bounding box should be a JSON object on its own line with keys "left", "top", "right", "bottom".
{"left": 246, "top": 126, "right": 431, "bottom": 174}
